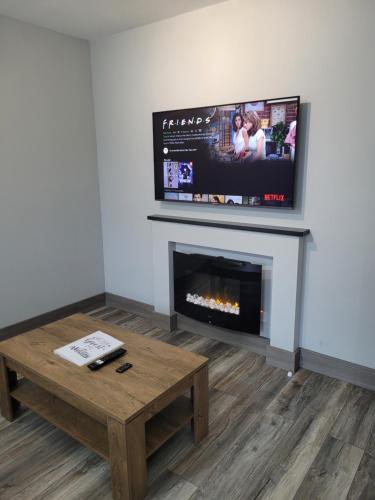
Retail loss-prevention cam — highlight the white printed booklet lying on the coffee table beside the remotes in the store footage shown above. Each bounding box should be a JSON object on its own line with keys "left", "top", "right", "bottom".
{"left": 53, "top": 330, "right": 124, "bottom": 366}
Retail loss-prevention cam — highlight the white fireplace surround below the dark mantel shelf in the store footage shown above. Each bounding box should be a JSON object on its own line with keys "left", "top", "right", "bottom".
{"left": 152, "top": 220, "right": 304, "bottom": 353}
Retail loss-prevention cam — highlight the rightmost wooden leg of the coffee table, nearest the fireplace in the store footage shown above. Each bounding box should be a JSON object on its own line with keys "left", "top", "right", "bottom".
{"left": 192, "top": 365, "right": 208, "bottom": 443}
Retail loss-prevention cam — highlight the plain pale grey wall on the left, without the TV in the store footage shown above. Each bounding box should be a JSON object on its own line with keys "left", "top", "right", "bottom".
{"left": 0, "top": 17, "right": 104, "bottom": 327}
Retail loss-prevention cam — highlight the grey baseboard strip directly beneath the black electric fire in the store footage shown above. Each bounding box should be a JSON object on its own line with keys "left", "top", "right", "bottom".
{"left": 177, "top": 313, "right": 269, "bottom": 356}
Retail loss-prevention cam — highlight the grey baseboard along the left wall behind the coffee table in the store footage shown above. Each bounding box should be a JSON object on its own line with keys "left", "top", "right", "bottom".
{"left": 0, "top": 293, "right": 105, "bottom": 340}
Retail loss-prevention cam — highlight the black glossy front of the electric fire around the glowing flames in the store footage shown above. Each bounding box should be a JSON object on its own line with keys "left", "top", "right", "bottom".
{"left": 173, "top": 250, "right": 262, "bottom": 335}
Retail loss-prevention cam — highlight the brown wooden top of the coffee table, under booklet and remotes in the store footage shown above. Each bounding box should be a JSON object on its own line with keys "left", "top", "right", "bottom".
{"left": 0, "top": 314, "right": 208, "bottom": 422}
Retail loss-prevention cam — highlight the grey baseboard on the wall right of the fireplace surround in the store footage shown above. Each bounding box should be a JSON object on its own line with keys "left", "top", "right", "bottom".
{"left": 300, "top": 348, "right": 375, "bottom": 391}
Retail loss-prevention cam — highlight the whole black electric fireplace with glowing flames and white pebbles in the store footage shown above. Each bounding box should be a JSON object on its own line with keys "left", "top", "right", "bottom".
{"left": 173, "top": 251, "right": 262, "bottom": 335}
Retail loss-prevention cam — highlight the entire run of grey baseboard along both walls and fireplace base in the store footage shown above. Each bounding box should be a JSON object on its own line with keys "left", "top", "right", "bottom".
{"left": 50, "top": 293, "right": 375, "bottom": 391}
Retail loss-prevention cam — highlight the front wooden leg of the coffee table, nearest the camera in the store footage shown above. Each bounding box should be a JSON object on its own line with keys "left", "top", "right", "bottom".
{"left": 108, "top": 418, "right": 147, "bottom": 500}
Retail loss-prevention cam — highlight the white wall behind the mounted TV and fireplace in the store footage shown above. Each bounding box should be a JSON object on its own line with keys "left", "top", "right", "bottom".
{"left": 92, "top": 0, "right": 375, "bottom": 367}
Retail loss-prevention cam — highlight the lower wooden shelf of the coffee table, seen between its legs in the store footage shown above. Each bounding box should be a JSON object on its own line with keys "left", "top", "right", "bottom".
{"left": 10, "top": 379, "right": 193, "bottom": 460}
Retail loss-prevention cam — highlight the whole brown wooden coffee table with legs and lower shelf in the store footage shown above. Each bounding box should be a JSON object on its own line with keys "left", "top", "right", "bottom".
{"left": 0, "top": 314, "right": 208, "bottom": 500}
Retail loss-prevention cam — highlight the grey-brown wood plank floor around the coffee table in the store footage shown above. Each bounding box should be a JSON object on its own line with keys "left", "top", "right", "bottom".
{"left": 0, "top": 307, "right": 375, "bottom": 500}
